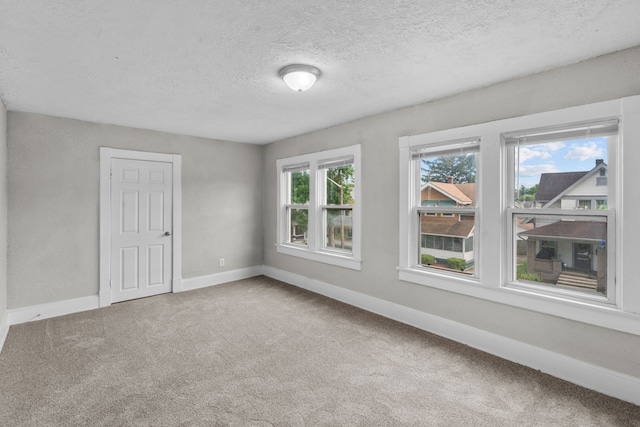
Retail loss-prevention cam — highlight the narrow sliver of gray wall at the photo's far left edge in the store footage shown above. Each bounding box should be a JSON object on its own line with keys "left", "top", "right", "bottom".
{"left": 0, "top": 100, "right": 7, "bottom": 323}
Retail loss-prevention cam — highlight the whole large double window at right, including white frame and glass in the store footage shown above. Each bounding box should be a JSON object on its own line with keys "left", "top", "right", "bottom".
{"left": 398, "top": 96, "right": 640, "bottom": 334}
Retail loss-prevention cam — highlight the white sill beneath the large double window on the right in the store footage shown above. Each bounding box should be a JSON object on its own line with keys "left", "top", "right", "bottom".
{"left": 398, "top": 267, "right": 640, "bottom": 335}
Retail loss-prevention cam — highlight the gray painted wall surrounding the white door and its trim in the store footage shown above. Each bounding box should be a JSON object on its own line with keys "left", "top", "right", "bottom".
{"left": 7, "top": 111, "right": 263, "bottom": 309}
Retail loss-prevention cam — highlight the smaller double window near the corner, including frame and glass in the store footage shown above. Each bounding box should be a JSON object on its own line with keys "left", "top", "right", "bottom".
{"left": 276, "top": 145, "right": 360, "bottom": 269}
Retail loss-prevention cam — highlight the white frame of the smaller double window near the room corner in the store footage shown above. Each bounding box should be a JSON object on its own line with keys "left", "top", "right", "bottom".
{"left": 276, "top": 145, "right": 362, "bottom": 270}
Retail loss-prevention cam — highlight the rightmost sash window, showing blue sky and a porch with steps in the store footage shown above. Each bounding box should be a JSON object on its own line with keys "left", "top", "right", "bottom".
{"left": 503, "top": 119, "right": 618, "bottom": 302}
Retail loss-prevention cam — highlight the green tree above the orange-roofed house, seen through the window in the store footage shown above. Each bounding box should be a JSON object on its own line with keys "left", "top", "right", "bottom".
{"left": 422, "top": 154, "right": 476, "bottom": 184}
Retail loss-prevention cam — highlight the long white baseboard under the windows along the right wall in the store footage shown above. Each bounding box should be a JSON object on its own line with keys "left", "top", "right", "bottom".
{"left": 263, "top": 266, "right": 640, "bottom": 405}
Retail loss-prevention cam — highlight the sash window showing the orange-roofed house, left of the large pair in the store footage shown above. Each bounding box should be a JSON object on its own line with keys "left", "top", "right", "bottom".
{"left": 404, "top": 138, "right": 479, "bottom": 277}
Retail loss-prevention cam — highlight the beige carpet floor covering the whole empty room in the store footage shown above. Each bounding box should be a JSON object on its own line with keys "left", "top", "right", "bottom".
{"left": 0, "top": 277, "right": 640, "bottom": 427}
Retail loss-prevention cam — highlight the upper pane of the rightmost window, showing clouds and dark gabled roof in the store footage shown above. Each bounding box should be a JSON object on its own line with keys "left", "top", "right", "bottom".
{"left": 513, "top": 137, "right": 609, "bottom": 209}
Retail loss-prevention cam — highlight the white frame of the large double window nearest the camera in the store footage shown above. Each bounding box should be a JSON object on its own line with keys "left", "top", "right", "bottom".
{"left": 398, "top": 96, "right": 640, "bottom": 335}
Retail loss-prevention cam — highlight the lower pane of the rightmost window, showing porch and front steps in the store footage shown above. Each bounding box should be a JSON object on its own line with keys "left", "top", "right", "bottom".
{"left": 514, "top": 214, "right": 607, "bottom": 294}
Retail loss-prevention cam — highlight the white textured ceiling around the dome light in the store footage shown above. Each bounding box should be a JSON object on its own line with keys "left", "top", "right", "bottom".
{"left": 0, "top": 0, "right": 640, "bottom": 143}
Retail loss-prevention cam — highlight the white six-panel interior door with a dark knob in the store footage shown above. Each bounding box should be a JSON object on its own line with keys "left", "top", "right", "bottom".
{"left": 111, "top": 159, "right": 173, "bottom": 302}
